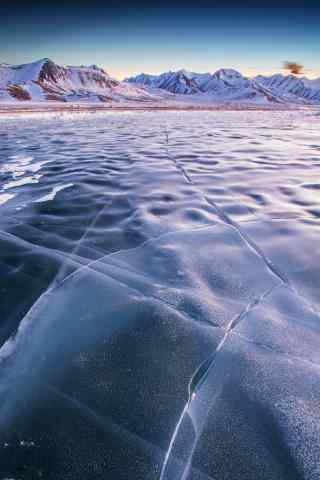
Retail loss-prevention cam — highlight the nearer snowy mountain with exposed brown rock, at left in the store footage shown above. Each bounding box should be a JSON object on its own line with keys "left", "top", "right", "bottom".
{"left": 0, "top": 58, "right": 157, "bottom": 102}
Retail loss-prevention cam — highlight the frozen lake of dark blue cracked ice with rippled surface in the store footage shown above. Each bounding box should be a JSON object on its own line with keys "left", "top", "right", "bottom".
{"left": 0, "top": 111, "right": 320, "bottom": 480}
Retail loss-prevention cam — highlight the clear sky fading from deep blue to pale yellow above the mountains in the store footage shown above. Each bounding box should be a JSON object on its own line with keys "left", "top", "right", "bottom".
{"left": 0, "top": 0, "right": 320, "bottom": 78}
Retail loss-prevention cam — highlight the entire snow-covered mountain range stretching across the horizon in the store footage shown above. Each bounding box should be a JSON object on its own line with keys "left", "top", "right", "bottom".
{"left": 0, "top": 58, "right": 320, "bottom": 105}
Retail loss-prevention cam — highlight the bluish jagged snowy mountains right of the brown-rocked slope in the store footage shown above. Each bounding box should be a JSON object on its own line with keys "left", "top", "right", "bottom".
{"left": 127, "top": 69, "right": 320, "bottom": 104}
